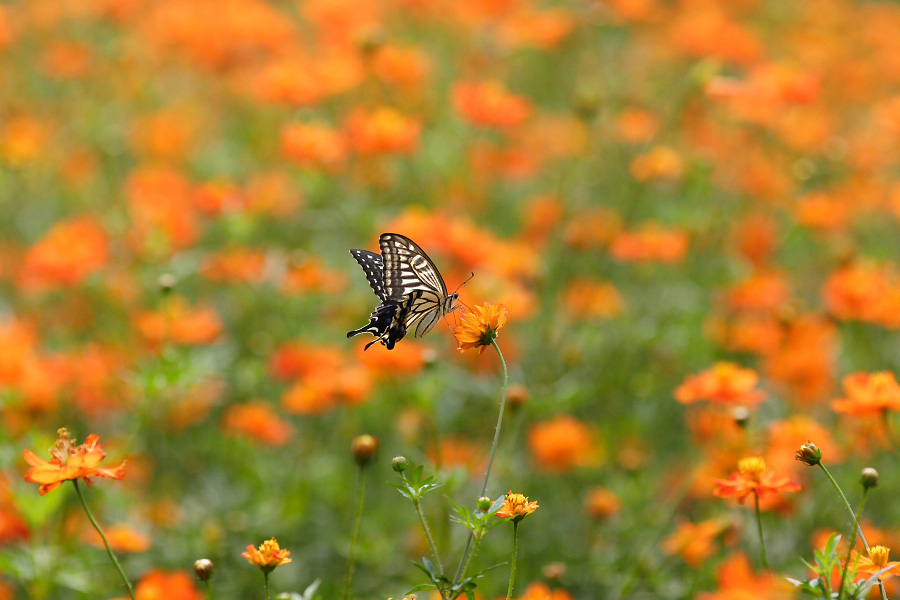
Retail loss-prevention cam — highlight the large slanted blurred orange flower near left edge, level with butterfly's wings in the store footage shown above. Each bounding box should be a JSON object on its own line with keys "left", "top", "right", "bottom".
{"left": 19, "top": 217, "right": 109, "bottom": 290}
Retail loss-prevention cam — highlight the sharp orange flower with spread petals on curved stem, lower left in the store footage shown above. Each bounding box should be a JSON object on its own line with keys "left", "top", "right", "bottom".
{"left": 24, "top": 427, "right": 125, "bottom": 496}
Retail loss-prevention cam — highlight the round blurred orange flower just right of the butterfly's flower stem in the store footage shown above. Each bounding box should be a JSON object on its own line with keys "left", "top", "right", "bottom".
{"left": 528, "top": 415, "right": 600, "bottom": 473}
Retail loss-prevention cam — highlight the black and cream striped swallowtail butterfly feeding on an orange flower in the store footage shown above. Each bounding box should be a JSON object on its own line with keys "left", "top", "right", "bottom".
{"left": 347, "top": 233, "right": 459, "bottom": 350}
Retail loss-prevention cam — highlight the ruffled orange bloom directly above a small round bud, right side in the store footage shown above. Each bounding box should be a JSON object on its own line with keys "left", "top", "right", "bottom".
{"left": 675, "top": 362, "right": 766, "bottom": 406}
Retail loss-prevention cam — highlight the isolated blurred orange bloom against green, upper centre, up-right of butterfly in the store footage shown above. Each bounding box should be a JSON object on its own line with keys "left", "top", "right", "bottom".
{"left": 452, "top": 81, "right": 531, "bottom": 128}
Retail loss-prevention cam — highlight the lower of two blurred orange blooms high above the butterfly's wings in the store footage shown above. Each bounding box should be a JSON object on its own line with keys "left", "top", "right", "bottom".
{"left": 344, "top": 107, "right": 422, "bottom": 156}
